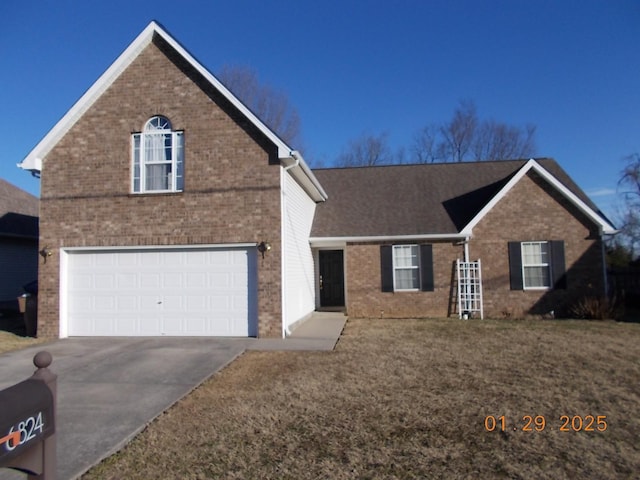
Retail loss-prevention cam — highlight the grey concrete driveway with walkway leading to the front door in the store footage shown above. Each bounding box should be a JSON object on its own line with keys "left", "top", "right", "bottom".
{"left": 0, "top": 312, "right": 347, "bottom": 480}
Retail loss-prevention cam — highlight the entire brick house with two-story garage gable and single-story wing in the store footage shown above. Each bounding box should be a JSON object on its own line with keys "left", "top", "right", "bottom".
{"left": 20, "top": 22, "right": 613, "bottom": 337}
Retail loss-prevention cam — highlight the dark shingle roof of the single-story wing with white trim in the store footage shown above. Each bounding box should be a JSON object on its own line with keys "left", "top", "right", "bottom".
{"left": 311, "top": 158, "right": 615, "bottom": 243}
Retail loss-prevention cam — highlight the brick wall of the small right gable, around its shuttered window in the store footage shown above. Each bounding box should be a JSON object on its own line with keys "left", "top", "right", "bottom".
{"left": 470, "top": 172, "right": 604, "bottom": 317}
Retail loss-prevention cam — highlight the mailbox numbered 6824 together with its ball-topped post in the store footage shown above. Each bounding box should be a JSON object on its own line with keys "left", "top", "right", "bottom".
{"left": 0, "top": 352, "right": 57, "bottom": 480}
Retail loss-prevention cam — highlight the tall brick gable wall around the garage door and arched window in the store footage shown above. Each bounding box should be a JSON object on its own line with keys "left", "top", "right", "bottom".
{"left": 39, "top": 40, "right": 282, "bottom": 337}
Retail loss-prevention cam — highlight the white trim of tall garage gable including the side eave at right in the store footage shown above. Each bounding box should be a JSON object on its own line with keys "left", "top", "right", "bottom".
{"left": 18, "top": 22, "right": 327, "bottom": 201}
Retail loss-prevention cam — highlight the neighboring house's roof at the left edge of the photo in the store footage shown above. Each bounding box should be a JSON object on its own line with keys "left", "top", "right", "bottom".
{"left": 0, "top": 179, "right": 39, "bottom": 238}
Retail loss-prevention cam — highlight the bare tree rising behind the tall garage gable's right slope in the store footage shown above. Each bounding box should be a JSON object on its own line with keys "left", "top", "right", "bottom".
{"left": 218, "top": 65, "right": 301, "bottom": 146}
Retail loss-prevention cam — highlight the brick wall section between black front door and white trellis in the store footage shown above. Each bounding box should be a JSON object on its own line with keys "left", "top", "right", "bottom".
{"left": 345, "top": 242, "right": 463, "bottom": 318}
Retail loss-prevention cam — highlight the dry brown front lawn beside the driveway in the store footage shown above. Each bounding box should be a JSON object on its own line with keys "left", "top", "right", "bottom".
{"left": 83, "top": 319, "right": 640, "bottom": 479}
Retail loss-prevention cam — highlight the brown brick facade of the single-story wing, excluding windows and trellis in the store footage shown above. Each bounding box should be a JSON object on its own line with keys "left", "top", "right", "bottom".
{"left": 345, "top": 173, "right": 604, "bottom": 318}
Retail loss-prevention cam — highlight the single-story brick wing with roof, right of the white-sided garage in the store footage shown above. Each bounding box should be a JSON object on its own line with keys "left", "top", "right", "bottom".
{"left": 310, "top": 159, "right": 615, "bottom": 318}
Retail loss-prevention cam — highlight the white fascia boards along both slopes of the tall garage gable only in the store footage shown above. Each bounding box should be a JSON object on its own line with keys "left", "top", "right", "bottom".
{"left": 18, "top": 21, "right": 298, "bottom": 171}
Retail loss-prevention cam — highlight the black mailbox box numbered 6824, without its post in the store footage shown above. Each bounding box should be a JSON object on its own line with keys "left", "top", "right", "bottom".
{"left": 0, "top": 379, "right": 55, "bottom": 465}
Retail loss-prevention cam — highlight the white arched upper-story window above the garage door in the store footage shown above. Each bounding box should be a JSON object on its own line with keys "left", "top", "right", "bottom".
{"left": 132, "top": 116, "right": 184, "bottom": 193}
